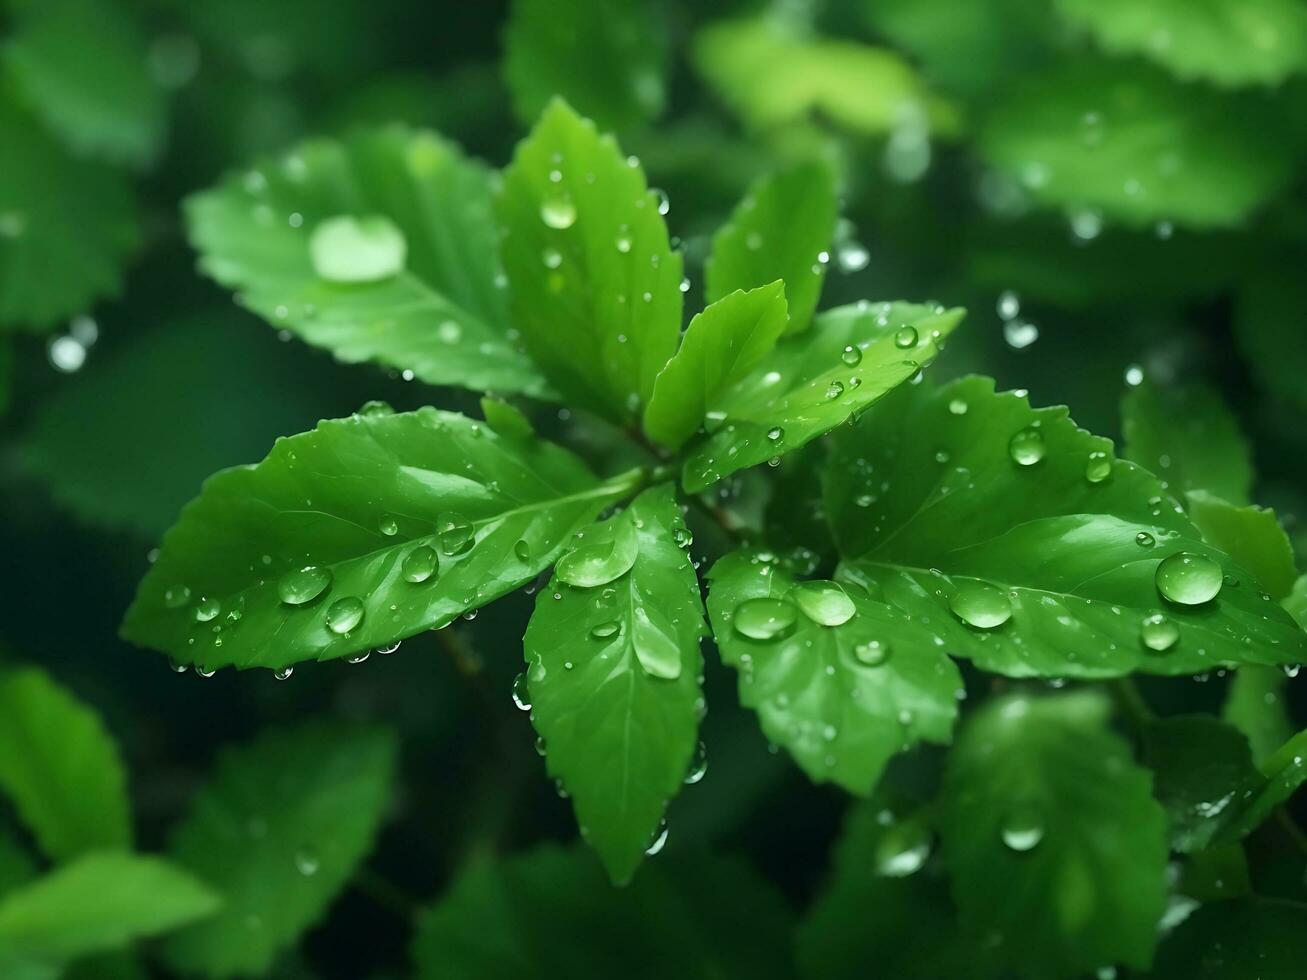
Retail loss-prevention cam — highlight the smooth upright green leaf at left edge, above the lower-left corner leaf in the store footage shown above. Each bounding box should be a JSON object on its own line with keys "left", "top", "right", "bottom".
{"left": 0, "top": 668, "right": 132, "bottom": 861}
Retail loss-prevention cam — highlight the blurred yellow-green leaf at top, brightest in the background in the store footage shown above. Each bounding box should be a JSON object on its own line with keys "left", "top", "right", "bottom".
{"left": 694, "top": 17, "right": 958, "bottom": 135}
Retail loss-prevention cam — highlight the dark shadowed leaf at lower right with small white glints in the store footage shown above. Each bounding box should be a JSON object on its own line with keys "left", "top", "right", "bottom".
{"left": 1142, "top": 715, "right": 1257, "bottom": 852}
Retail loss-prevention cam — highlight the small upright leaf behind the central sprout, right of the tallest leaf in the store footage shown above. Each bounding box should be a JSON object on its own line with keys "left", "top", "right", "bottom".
{"left": 703, "top": 163, "right": 836, "bottom": 333}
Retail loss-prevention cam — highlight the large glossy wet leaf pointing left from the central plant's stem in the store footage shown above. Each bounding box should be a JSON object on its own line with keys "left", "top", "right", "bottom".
{"left": 122, "top": 409, "right": 634, "bottom": 669}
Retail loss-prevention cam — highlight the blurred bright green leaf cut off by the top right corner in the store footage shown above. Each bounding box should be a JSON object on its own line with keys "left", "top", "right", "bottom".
{"left": 1057, "top": 0, "right": 1307, "bottom": 88}
